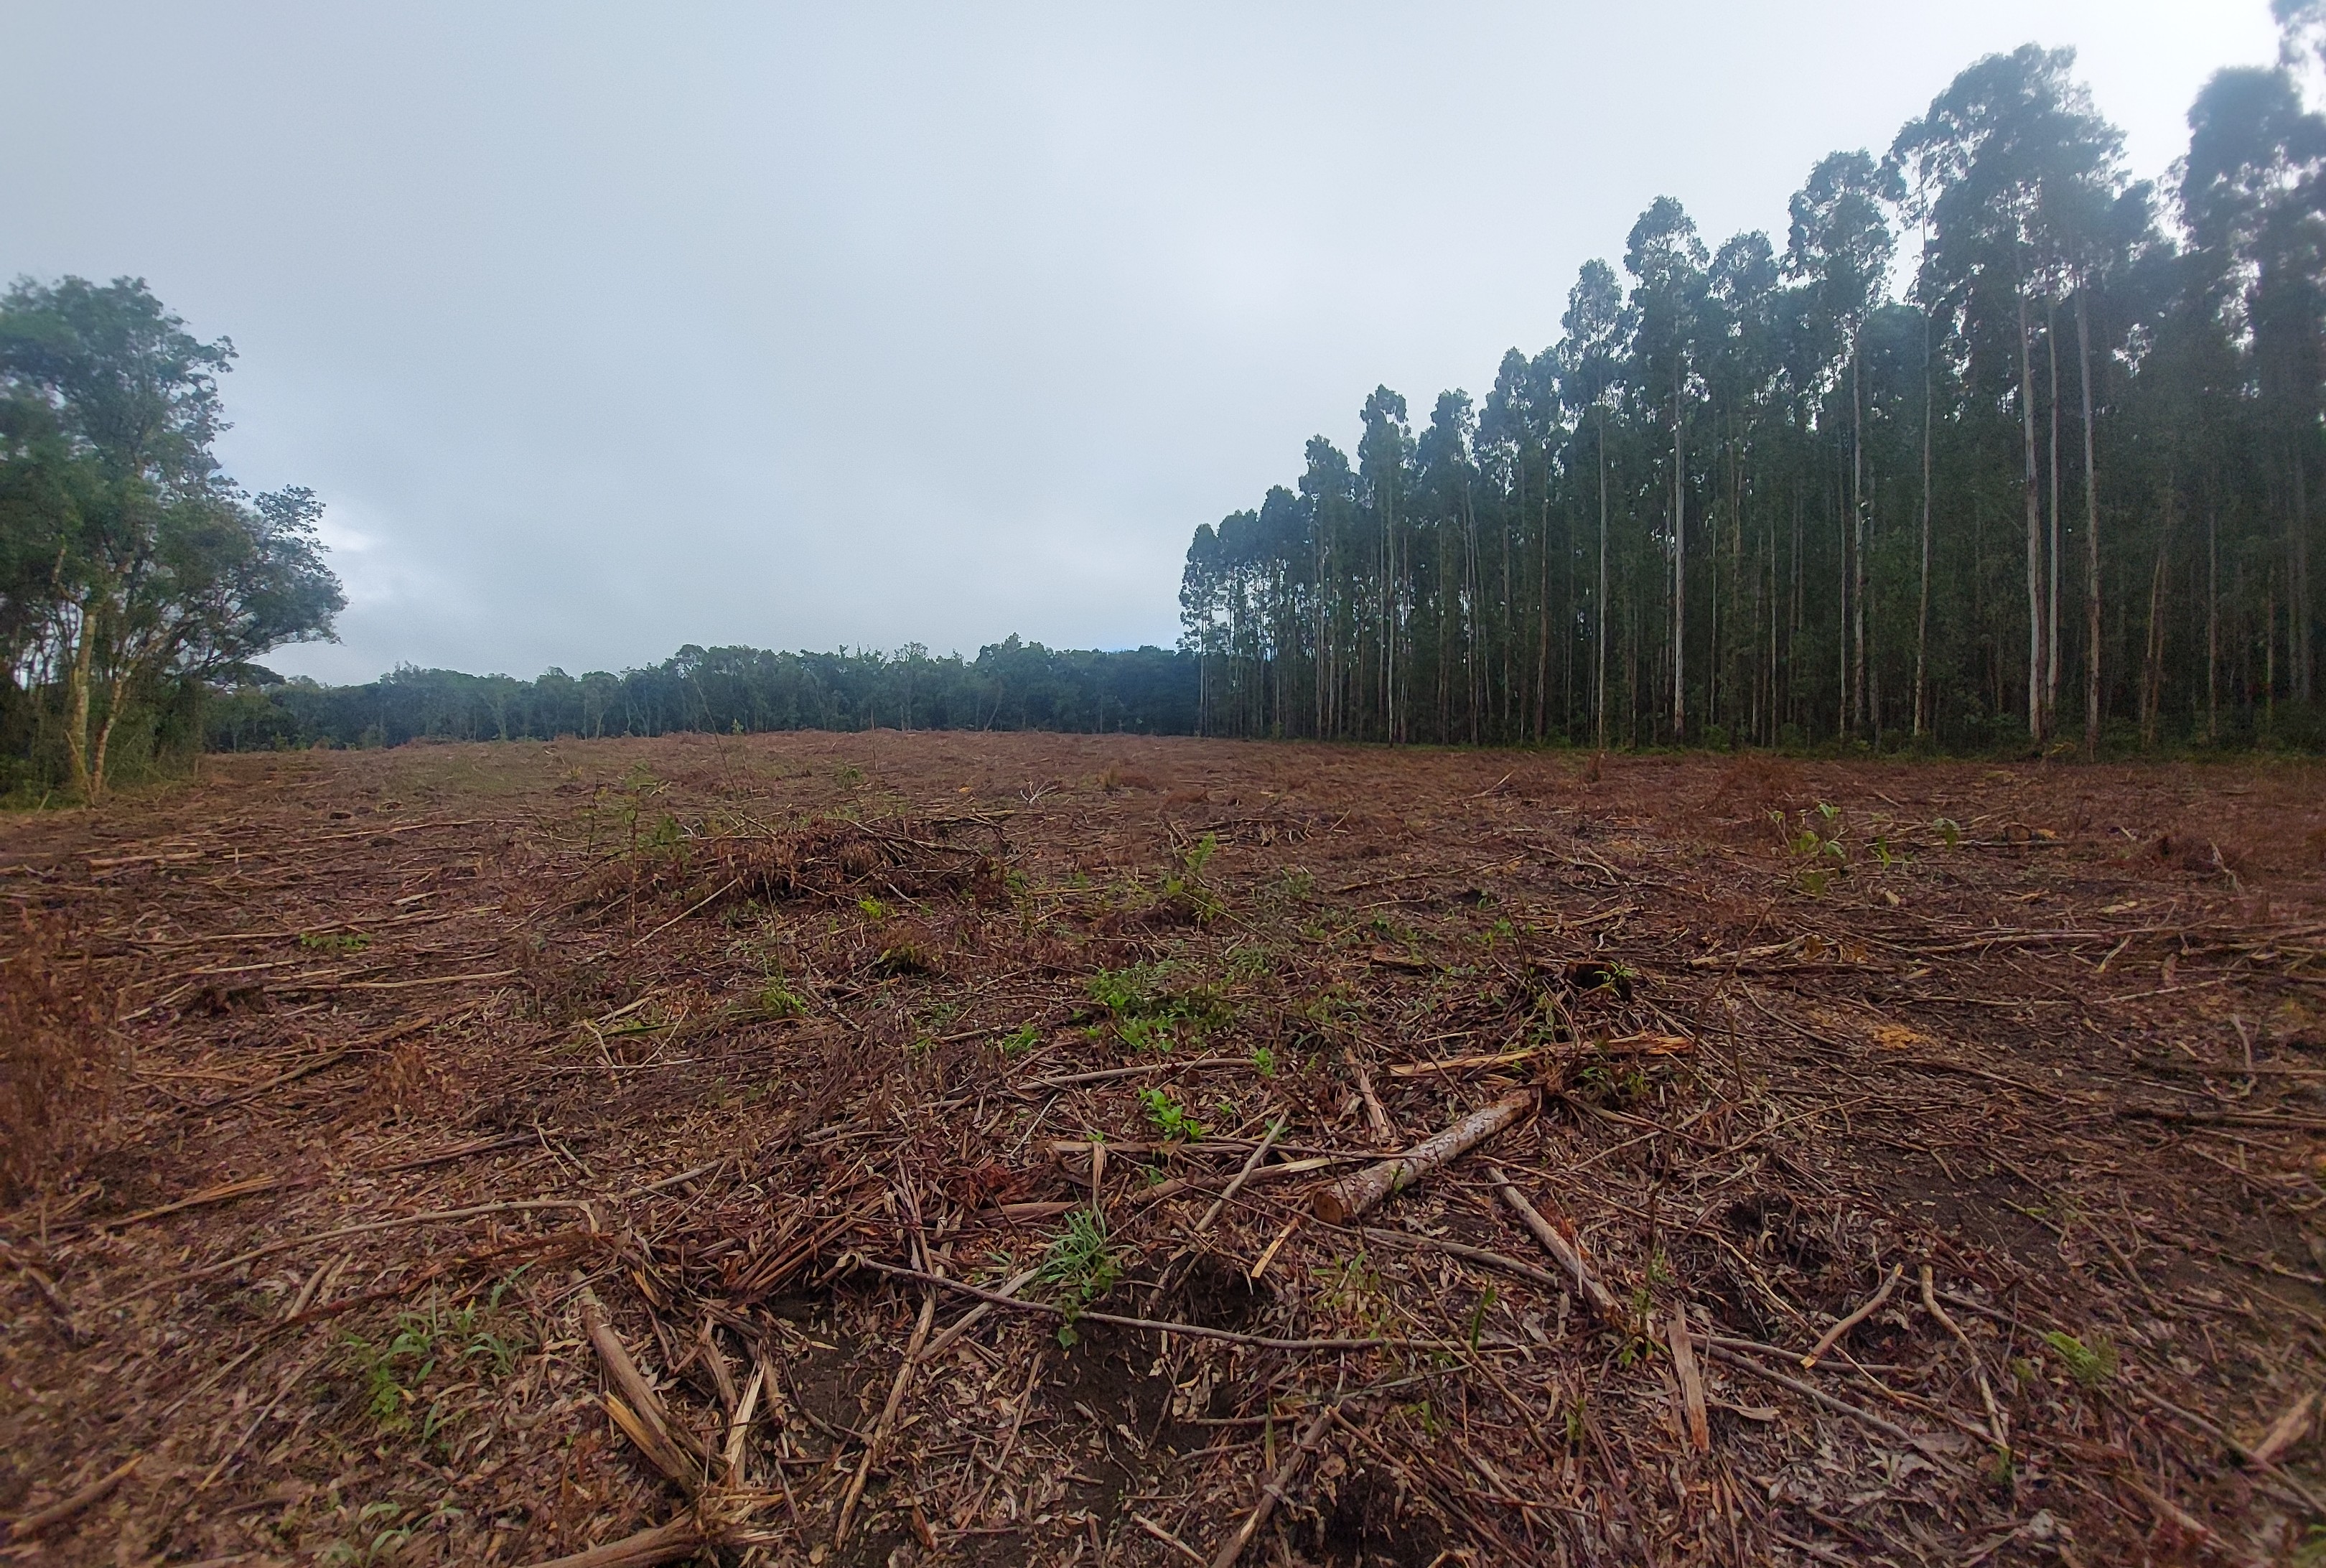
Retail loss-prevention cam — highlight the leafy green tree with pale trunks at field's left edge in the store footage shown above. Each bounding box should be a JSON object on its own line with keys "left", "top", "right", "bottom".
{"left": 0, "top": 277, "right": 345, "bottom": 801}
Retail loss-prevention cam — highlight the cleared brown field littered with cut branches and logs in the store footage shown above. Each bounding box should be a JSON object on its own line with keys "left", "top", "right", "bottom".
{"left": 0, "top": 733, "right": 2326, "bottom": 1566}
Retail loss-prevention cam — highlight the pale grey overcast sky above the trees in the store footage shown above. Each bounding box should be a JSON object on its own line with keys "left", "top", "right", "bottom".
{"left": 0, "top": 0, "right": 2275, "bottom": 681}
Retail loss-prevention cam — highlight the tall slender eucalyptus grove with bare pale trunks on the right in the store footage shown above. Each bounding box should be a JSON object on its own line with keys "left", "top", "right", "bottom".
{"left": 1182, "top": 42, "right": 2326, "bottom": 749}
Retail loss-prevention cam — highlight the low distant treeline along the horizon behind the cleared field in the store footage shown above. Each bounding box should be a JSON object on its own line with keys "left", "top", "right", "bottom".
{"left": 202, "top": 638, "right": 1198, "bottom": 752}
